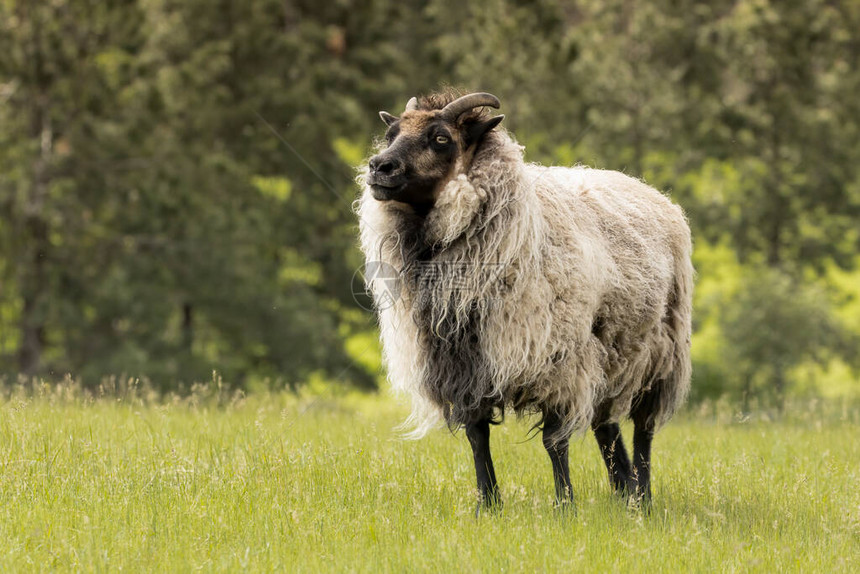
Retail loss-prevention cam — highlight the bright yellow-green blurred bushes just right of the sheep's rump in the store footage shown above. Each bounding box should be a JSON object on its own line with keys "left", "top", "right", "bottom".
{"left": 693, "top": 242, "right": 860, "bottom": 410}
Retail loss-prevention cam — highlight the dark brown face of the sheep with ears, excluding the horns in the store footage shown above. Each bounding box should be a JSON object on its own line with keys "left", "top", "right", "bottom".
{"left": 367, "top": 106, "right": 502, "bottom": 213}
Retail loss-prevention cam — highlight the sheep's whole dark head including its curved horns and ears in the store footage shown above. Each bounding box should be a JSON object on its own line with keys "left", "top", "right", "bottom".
{"left": 367, "top": 93, "right": 504, "bottom": 213}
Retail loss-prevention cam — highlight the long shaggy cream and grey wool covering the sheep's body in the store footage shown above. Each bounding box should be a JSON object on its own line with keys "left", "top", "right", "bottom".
{"left": 357, "top": 130, "right": 694, "bottom": 437}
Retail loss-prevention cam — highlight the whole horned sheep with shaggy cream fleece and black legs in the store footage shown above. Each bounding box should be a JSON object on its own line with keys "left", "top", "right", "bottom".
{"left": 356, "top": 90, "right": 694, "bottom": 511}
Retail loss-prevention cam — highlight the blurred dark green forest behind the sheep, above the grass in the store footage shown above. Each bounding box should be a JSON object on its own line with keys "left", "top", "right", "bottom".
{"left": 0, "top": 0, "right": 860, "bottom": 406}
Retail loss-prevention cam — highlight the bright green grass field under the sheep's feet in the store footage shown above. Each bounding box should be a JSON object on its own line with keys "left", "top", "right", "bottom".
{"left": 0, "top": 388, "right": 860, "bottom": 572}
